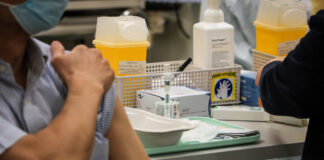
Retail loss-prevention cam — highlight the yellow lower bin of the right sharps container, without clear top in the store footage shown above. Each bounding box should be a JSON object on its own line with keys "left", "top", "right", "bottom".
{"left": 254, "top": 21, "right": 308, "bottom": 56}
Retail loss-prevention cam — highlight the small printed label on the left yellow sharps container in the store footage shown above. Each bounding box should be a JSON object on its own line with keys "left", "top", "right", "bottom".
{"left": 118, "top": 61, "right": 146, "bottom": 74}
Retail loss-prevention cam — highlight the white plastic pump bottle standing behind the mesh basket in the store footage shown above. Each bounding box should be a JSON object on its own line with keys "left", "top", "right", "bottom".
{"left": 193, "top": 0, "right": 234, "bottom": 69}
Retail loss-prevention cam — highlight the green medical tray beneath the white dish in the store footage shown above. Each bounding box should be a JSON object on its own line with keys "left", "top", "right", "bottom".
{"left": 145, "top": 117, "right": 261, "bottom": 156}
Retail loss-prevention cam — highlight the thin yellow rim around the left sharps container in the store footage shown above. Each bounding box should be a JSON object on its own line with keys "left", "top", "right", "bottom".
{"left": 92, "top": 40, "right": 150, "bottom": 48}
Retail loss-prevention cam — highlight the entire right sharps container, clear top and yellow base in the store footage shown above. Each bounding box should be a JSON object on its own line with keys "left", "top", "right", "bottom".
{"left": 254, "top": 0, "right": 308, "bottom": 56}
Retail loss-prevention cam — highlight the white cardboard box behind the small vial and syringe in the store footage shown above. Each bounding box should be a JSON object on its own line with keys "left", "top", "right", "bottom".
{"left": 136, "top": 86, "right": 211, "bottom": 117}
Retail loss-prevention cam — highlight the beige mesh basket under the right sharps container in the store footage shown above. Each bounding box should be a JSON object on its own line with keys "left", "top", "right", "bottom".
{"left": 252, "top": 49, "right": 276, "bottom": 71}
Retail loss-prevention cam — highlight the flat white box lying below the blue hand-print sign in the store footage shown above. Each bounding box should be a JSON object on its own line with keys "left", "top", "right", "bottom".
{"left": 212, "top": 105, "right": 270, "bottom": 122}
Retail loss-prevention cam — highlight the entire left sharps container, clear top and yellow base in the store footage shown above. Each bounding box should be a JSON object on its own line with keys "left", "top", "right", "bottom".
{"left": 93, "top": 16, "right": 149, "bottom": 76}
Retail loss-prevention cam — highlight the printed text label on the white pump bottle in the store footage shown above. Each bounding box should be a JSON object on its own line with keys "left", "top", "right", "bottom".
{"left": 211, "top": 38, "right": 231, "bottom": 68}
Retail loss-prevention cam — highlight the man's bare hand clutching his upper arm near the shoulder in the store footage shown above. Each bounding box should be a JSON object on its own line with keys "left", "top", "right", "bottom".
{"left": 52, "top": 41, "right": 114, "bottom": 93}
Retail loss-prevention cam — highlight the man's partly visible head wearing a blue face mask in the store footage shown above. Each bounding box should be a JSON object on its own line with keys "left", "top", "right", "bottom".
{"left": 0, "top": 0, "right": 68, "bottom": 35}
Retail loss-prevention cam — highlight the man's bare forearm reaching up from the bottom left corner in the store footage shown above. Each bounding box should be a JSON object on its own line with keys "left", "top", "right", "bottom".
{"left": 1, "top": 84, "right": 103, "bottom": 160}
